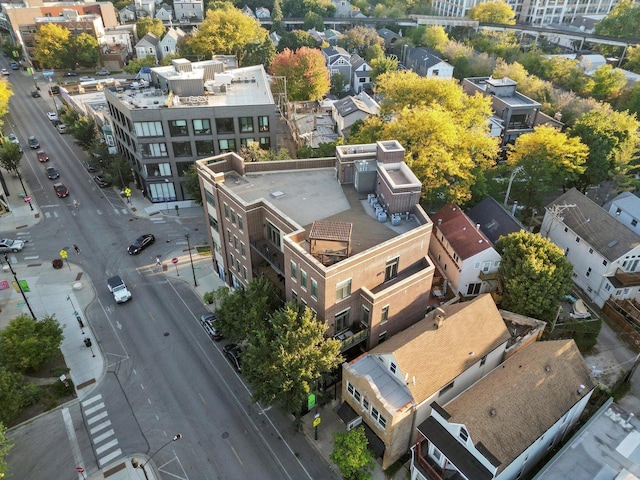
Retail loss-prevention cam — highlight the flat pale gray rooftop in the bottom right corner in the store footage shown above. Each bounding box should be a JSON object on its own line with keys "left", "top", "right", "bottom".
{"left": 533, "top": 398, "right": 640, "bottom": 480}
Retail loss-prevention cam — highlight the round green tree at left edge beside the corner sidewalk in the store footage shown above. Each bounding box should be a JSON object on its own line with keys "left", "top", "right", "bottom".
{"left": 0, "top": 315, "right": 64, "bottom": 373}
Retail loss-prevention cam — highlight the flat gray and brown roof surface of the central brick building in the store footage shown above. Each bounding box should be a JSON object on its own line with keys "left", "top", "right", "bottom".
{"left": 225, "top": 168, "right": 420, "bottom": 256}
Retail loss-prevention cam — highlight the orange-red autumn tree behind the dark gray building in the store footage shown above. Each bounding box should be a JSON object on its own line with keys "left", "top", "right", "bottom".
{"left": 270, "top": 47, "right": 331, "bottom": 101}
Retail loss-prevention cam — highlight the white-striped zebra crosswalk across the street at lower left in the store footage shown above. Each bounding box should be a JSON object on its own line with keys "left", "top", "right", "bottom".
{"left": 80, "top": 394, "right": 123, "bottom": 468}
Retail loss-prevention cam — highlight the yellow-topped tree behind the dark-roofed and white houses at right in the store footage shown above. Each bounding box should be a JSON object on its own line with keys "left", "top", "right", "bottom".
{"left": 507, "top": 125, "right": 589, "bottom": 210}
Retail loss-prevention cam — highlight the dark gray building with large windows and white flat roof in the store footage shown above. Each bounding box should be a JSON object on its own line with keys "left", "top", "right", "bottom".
{"left": 104, "top": 59, "right": 277, "bottom": 202}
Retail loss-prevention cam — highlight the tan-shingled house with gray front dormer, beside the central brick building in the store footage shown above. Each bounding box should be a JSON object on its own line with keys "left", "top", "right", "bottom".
{"left": 338, "top": 295, "right": 511, "bottom": 470}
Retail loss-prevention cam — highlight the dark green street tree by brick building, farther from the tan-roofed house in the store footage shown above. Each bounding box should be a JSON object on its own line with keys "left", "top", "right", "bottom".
{"left": 215, "top": 277, "right": 282, "bottom": 343}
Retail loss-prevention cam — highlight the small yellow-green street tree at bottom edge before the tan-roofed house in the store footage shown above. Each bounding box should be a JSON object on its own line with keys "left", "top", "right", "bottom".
{"left": 329, "top": 425, "right": 374, "bottom": 480}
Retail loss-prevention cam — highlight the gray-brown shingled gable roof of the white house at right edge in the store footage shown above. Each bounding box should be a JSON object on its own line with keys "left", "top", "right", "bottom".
{"left": 542, "top": 188, "right": 640, "bottom": 261}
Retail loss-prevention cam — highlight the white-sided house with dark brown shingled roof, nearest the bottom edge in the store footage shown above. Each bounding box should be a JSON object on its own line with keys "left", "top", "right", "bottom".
{"left": 411, "top": 340, "right": 596, "bottom": 480}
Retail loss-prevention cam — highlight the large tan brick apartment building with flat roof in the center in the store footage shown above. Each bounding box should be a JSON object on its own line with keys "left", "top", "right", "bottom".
{"left": 197, "top": 140, "right": 434, "bottom": 351}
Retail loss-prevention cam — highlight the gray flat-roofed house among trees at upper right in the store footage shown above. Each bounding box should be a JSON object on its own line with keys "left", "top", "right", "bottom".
{"left": 462, "top": 77, "right": 564, "bottom": 147}
